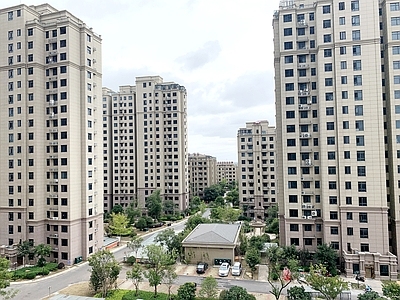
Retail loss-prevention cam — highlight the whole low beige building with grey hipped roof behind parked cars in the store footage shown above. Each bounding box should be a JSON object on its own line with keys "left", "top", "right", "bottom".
{"left": 182, "top": 224, "right": 241, "bottom": 265}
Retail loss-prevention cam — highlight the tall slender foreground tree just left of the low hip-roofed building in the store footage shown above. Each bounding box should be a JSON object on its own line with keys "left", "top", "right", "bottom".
{"left": 144, "top": 244, "right": 175, "bottom": 297}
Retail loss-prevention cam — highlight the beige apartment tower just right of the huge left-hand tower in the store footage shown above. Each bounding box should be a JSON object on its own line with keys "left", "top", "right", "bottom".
{"left": 103, "top": 76, "right": 189, "bottom": 211}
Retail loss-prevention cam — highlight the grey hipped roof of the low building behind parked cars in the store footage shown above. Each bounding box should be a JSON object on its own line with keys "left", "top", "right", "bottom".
{"left": 183, "top": 224, "right": 240, "bottom": 244}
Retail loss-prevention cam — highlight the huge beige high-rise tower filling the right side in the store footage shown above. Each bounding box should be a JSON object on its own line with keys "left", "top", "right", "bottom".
{"left": 273, "top": 0, "right": 400, "bottom": 278}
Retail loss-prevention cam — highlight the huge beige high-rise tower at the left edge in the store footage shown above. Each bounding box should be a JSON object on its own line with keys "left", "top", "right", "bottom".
{"left": 0, "top": 4, "right": 103, "bottom": 264}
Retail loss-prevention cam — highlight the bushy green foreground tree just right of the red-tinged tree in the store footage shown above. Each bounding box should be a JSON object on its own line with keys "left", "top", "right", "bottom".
{"left": 306, "top": 264, "right": 349, "bottom": 300}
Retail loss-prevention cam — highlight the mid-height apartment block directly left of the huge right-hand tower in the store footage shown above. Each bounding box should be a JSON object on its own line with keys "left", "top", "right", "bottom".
{"left": 237, "top": 121, "right": 277, "bottom": 220}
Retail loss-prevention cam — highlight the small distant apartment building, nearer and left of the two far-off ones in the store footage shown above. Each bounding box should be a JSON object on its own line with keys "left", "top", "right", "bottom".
{"left": 189, "top": 153, "right": 218, "bottom": 197}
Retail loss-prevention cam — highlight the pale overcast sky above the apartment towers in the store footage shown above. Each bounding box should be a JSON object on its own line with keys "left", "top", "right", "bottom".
{"left": 6, "top": 0, "right": 279, "bottom": 162}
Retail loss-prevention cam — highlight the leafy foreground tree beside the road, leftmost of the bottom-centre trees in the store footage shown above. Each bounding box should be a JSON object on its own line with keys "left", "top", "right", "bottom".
{"left": 88, "top": 249, "right": 121, "bottom": 297}
